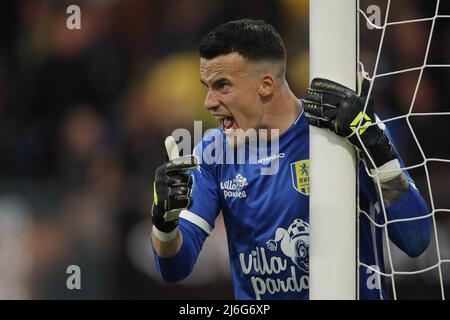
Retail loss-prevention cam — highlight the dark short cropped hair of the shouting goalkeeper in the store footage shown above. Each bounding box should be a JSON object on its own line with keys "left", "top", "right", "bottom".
{"left": 199, "top": 19, "right": 286, "bottom": 62}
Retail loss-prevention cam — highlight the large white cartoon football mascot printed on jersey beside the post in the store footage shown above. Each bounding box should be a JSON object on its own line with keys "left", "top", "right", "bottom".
{"left": 267, "top": 219, "right": 309, "bottom": 273}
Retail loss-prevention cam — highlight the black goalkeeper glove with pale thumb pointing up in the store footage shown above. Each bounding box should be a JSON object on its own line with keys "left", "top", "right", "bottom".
{"left": 152, "top": 136, "right": 198, "bottom": 234}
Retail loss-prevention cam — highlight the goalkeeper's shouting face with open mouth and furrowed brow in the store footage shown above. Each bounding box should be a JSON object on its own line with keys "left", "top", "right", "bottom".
{"left": 200, "top": 53, "right": 263, "bottom": 133}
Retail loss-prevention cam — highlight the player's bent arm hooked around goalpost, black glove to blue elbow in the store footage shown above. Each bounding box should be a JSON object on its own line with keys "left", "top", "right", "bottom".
{"left": 304, "top": 79, "right": 431, "bottom": 256}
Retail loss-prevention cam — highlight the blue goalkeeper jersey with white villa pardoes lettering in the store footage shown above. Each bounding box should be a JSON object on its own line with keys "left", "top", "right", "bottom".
{"left": 155, "top": 108, "right": 431, "bottom": 300}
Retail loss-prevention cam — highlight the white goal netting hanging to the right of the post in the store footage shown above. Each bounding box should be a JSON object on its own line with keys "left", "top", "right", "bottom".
{"left": 358, "top": 0, "right": 450, "bottom": 299}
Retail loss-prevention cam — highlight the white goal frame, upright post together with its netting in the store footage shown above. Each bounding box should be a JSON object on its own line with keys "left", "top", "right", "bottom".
{"left": 309, "top": 0, "right": 450, "bottom": 299}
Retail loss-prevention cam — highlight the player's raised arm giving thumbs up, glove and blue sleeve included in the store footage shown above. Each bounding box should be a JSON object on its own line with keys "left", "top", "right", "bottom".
{"left": 151, "top": 137, "right": 218, "bottom": 283}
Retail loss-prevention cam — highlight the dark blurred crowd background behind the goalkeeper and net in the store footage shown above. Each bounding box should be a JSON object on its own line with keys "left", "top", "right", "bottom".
{"left": 0, "top": 0, "right": 450, "bottom": 299}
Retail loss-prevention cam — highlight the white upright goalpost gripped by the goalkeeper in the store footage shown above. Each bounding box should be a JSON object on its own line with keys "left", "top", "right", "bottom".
{"left": 309, "top": 0, "right": 357, "bottom": 300}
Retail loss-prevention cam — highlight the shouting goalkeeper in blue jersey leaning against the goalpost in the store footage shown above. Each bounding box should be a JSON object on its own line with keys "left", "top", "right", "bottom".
{"left": 152, "top": 19, "right": 431, "bottom": 299}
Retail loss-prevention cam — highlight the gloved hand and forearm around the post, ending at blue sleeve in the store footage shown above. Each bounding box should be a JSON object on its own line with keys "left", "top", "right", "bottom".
{"left": 304, "top": 79, "right": 409, "bottom": 206}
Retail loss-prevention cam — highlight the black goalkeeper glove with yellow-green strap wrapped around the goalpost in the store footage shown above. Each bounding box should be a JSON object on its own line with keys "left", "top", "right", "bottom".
{"left": 304, "top": 78, "right": 396, "bottom": 169}
